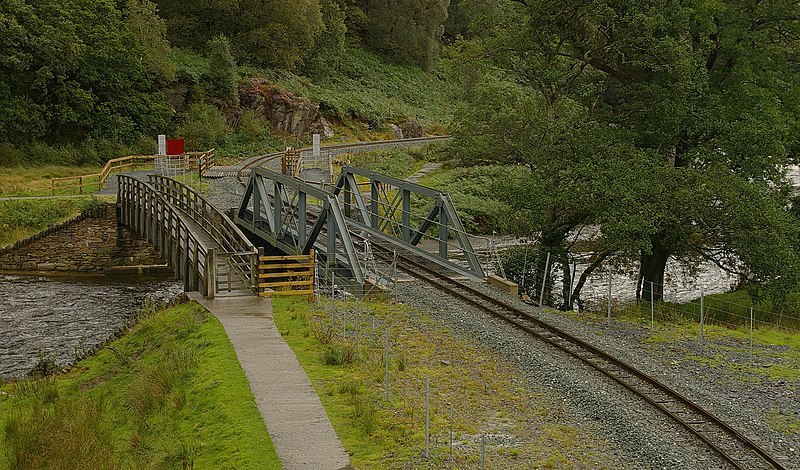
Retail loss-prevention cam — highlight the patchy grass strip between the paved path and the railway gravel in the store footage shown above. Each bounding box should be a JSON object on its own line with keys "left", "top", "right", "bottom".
{"left": 273, "top": 299, "right": 614, "bottom": 468}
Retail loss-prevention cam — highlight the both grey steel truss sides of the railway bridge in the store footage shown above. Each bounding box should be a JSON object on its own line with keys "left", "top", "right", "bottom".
{"left": 235, "top": 166, "right": 484, "bottom": 287}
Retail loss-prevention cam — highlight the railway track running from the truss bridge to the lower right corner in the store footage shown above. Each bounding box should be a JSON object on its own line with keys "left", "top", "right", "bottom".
{"left": 366, "top": 244, "right": 787, "bottom": 470}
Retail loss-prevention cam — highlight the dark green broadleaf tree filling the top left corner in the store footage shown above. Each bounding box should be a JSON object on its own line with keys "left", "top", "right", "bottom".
{"left": 0, "top": 0, "right": 169, "bottom": 144}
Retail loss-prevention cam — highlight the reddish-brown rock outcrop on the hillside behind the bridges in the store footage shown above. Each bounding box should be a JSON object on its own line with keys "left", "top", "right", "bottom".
{"left": 239, "top": 78, "right": 333, "bottom": 138}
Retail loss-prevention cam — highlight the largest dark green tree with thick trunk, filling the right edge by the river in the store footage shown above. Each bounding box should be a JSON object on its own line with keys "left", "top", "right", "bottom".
{"left": 450, "top": 0, "right": 800, "bottom": 306}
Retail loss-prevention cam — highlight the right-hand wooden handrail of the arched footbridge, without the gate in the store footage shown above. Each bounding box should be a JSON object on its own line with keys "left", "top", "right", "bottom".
{"left": 148, "top": 175, "right": 258, "bottom": 288}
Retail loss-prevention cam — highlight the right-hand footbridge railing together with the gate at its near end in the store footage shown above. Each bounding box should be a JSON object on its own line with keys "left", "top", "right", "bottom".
{"left": 149, "top": 175, "right": 253, "bottom": 292}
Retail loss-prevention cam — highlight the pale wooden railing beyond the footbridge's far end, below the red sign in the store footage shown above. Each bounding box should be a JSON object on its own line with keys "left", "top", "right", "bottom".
{"left": 50, "top": 149, "right": 215, "bottom": 195}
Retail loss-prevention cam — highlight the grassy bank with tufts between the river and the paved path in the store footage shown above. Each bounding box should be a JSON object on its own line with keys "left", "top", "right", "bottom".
{"left": 0, "top": 302, "right": 280, "bottom": 469}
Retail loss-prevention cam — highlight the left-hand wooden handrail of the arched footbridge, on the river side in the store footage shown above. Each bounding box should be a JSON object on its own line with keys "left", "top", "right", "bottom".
{"left": 117, "top": 175, "right": 216, "bottom": 297}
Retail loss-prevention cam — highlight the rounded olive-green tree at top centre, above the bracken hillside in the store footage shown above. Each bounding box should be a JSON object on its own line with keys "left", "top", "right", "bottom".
{"left": 366, "top": 0, "right": 449, "bottom": 69}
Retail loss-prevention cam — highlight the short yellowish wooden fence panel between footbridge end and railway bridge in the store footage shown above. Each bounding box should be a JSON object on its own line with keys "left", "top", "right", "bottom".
{"left": 258, "top": 250, "right": 314, "bottom": 303}
